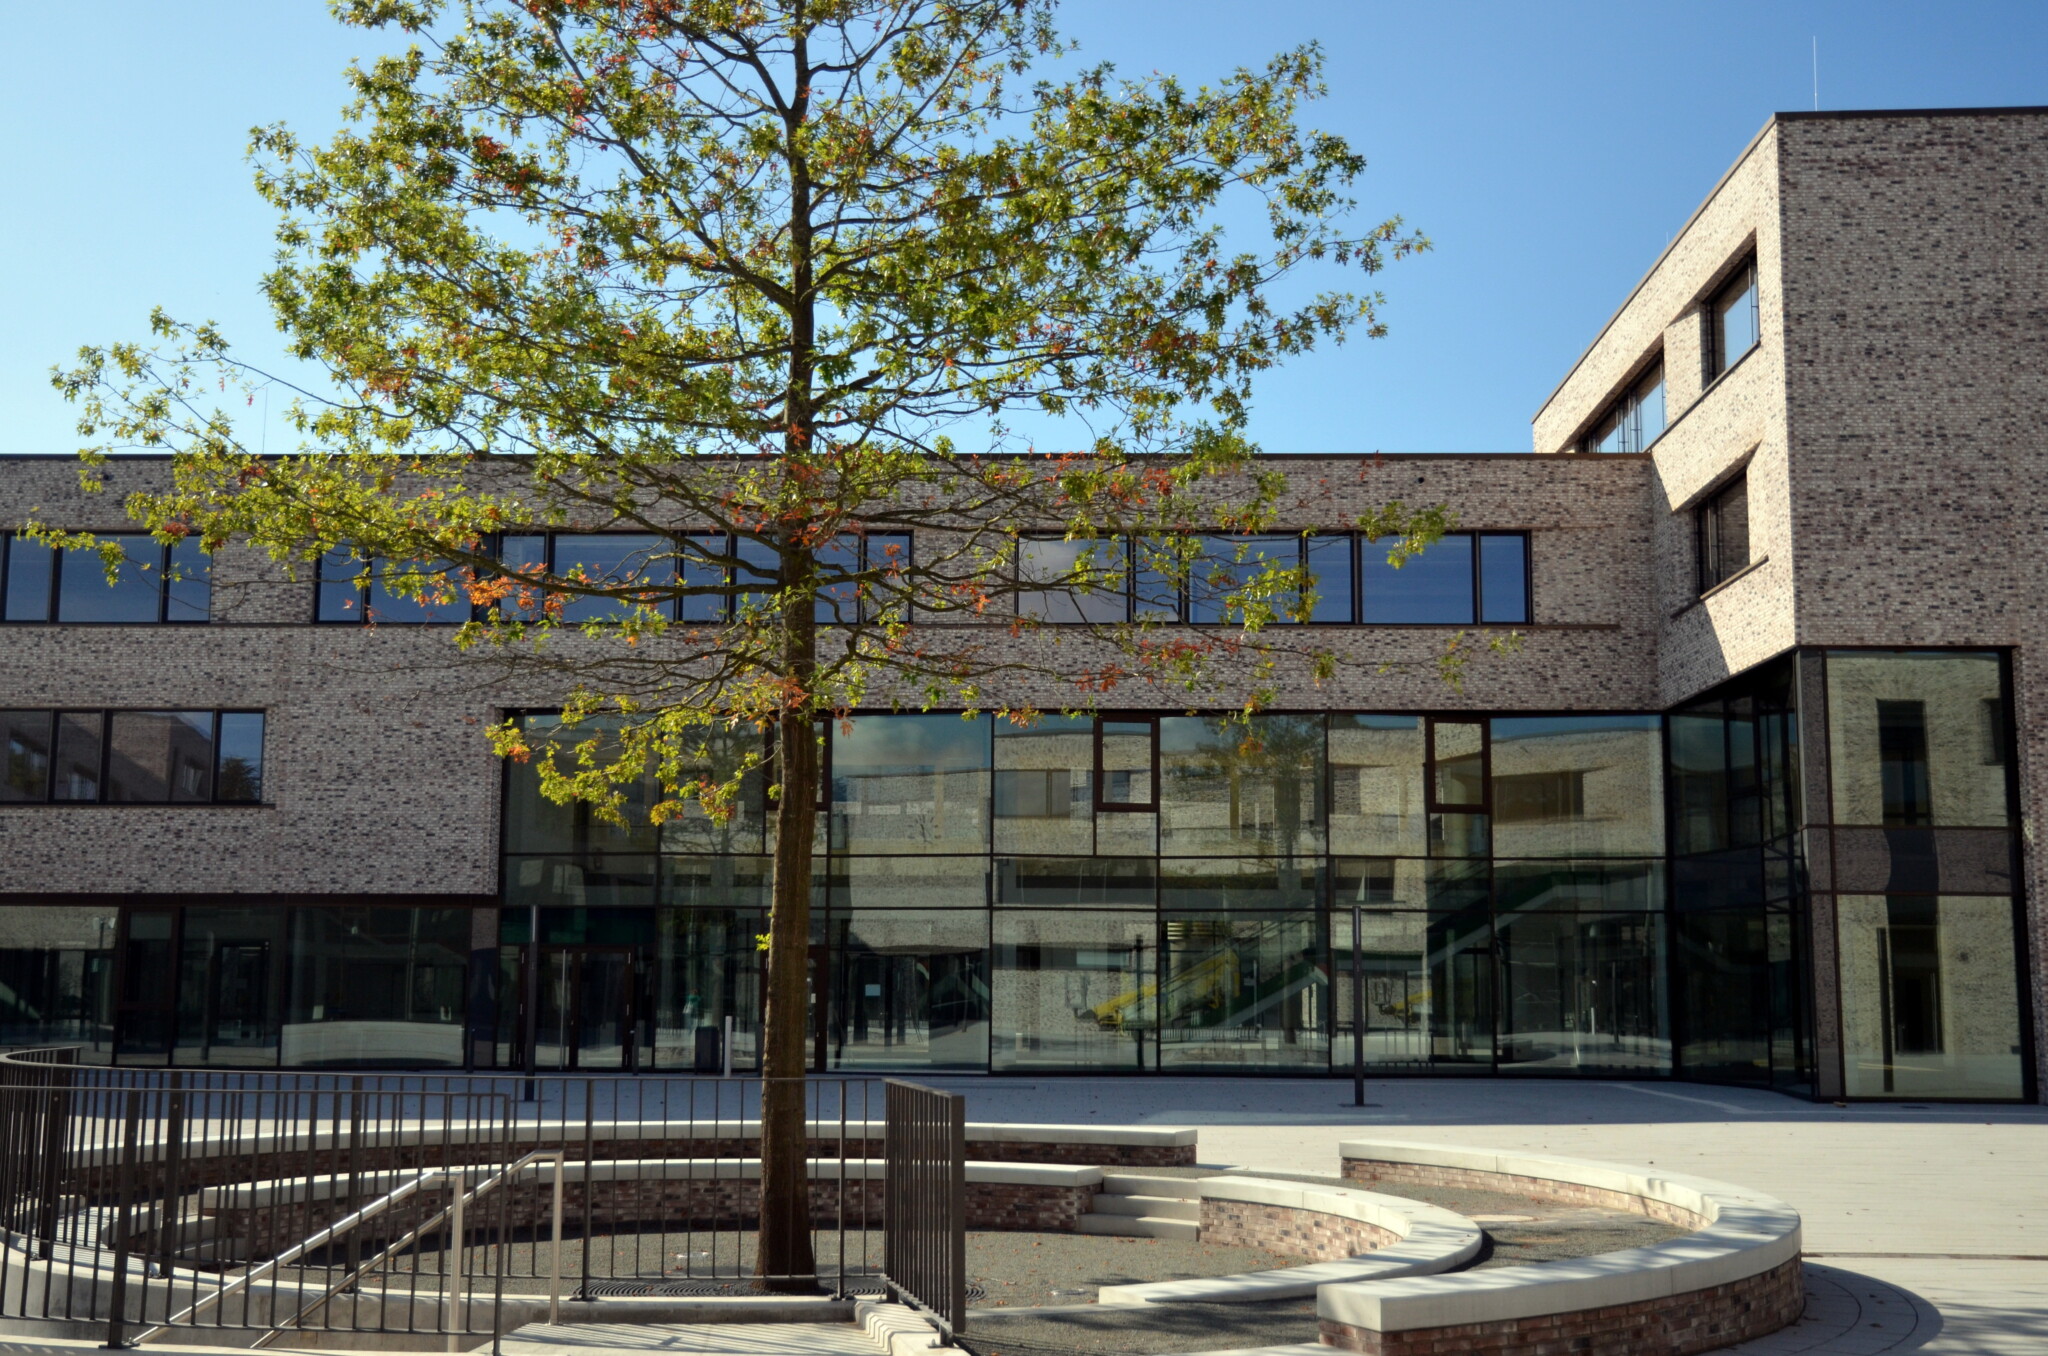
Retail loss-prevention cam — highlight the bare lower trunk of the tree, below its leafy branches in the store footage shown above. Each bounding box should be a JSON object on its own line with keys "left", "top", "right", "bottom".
{"left": 754, "top": 713, "right": 817, "bottom": 1293}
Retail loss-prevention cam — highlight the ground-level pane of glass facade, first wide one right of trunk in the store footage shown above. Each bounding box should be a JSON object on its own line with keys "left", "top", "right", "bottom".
{"left": 827, "top": 909, "right": 989, "bottom": 1069}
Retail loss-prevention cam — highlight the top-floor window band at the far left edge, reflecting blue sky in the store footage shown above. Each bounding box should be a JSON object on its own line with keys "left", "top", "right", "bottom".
{"left": 0, "top": 533, "right": 213, "bottom": 623}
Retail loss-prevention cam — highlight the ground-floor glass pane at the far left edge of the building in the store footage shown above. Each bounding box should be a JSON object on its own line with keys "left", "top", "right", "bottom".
{"left": 0, "top": 905, "right": 117, "bottom": 1063}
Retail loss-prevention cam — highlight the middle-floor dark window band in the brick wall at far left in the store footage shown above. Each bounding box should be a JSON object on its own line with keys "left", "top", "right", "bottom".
{"left": 0, "top": 711, "right": 262, "bottom": 805}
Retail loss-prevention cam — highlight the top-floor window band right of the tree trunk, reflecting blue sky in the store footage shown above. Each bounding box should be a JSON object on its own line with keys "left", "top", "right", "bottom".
{"left": 1018, "top": 533, "right": 1530, "bottom": 627}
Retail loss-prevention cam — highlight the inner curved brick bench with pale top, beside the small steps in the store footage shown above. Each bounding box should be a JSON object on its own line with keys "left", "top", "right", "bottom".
{"left": 1098, "top": 1176, "right": 1485, "bottom": 1305}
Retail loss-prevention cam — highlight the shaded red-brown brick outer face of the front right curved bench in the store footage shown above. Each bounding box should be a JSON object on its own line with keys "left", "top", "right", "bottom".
{"left": 1323, "top": 1258, "right": 1806, "bottom": 1356}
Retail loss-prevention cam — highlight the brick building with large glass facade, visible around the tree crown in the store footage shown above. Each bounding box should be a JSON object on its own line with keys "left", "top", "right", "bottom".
{"left": 0, "top": 109, "right": 2048, "bottom": 1100}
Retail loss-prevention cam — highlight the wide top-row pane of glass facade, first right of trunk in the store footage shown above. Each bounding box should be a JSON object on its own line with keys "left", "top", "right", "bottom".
{"left": 831, "top": 715, "right": 989, "bottom": 852}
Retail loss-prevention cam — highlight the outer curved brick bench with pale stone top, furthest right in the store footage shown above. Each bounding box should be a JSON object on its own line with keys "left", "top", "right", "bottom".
{"left": 1317, "top": 1141, "right": 1804, "bottom": 1356}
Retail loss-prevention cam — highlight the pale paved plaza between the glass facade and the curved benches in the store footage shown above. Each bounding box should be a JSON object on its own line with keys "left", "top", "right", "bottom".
{"left": 909, "top": 1077, "right": 2048, "bottom": 1356}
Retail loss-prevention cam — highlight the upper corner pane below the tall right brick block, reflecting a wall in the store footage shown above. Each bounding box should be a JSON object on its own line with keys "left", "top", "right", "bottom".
{"left": 1827, "top": 649, "right": 2011, "bottom": 828}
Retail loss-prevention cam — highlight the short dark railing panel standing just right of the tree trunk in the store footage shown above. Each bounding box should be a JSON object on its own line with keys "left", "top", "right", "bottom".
{"left": 883, "top": 1079, "right": 967, "bottom": 1338}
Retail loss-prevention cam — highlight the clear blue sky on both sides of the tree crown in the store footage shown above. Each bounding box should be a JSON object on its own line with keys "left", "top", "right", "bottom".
{"left": 0, "top": 0, "right": 2048, "bottom": 453}
